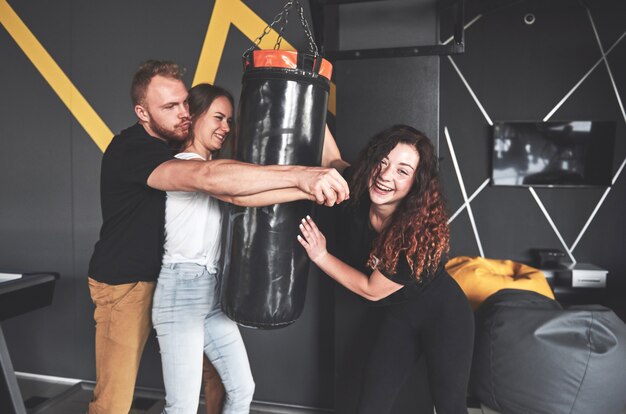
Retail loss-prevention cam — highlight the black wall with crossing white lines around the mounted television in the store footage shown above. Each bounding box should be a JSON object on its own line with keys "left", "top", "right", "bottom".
{"left": 440, "top": 0, "right": 626, "bottom": 278}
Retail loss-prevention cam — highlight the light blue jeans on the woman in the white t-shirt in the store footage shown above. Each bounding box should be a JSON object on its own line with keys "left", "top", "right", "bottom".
{"left": 152, "top": 263, "right": 254, "bottom": 414}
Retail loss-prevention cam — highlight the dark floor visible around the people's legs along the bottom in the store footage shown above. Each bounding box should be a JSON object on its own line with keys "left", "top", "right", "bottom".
{"left": 13, "top": 375, "right": 498, "bottom": 414}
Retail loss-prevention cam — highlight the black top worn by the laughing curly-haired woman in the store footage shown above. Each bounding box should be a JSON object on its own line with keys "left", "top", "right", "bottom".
{"left": 338, "top": 168, "right": 444, "bottom": 306}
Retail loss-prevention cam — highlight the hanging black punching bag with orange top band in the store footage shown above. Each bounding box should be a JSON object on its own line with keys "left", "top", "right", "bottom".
{"left": 222, "top": 50, "right": 332, "bottom": 329}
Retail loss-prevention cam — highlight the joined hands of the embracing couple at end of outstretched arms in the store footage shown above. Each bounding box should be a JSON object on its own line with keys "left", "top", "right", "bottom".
{"left": 298, "top": 167, "right": 350, "bottom": 207}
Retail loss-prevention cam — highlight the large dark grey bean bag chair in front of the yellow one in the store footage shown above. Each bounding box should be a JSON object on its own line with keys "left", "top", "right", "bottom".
{"left": 470, "top": 289, "right": 626, "bottom": 414}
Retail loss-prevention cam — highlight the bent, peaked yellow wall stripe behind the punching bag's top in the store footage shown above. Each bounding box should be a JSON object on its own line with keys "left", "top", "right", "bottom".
{"left": 193, "top": 0, "right": 337, "bottom": 115}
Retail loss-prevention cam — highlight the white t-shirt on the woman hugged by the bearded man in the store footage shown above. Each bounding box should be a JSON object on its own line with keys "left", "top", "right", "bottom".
{"left": 163, "top": 152, "right": 222, "bottom": 271}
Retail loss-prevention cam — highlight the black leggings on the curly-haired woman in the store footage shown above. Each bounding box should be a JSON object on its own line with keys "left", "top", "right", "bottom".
{"left": 358, "top": 272, "right": 474, "bottom": 414}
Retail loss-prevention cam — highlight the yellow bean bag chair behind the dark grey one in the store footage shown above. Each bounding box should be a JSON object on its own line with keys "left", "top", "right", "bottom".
{"left": 446, "top": 256, "right": 554, "bottom": 310}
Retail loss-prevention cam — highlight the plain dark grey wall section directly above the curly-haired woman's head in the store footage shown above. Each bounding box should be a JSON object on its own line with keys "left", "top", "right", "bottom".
{"left": 334, "top": 56, "right": 439, "bottom": 162}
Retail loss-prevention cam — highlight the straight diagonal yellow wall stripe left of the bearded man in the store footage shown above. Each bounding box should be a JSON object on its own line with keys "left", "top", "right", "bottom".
{"left": 0, "top": 0, "right": 113, "bottom": 151}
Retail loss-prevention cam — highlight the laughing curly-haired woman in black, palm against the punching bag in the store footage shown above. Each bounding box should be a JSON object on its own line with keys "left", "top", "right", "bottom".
{"left": 298, "top": 125, "right": 474, "bottom": 414}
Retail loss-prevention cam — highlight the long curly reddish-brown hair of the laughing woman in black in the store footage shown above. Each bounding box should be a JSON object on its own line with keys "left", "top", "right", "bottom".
{"left": 350, "top": 125, "right": 450, "bottom": 279}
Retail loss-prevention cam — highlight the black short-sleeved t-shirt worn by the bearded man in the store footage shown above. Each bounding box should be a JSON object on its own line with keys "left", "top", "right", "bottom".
{"left": 89, "top": 124, "right": 173, "bottom": 285}
